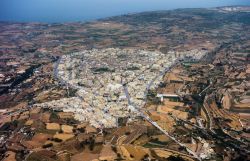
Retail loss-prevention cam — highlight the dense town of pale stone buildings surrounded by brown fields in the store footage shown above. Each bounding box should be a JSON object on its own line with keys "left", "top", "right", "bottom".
{"left": 36, "top": 48, "right": 206, "bottom": 127}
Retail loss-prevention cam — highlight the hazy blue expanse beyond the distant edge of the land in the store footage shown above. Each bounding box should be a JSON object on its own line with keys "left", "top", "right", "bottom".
{"left": 0, "top": 0, "right": 250, "bottom": 23}
